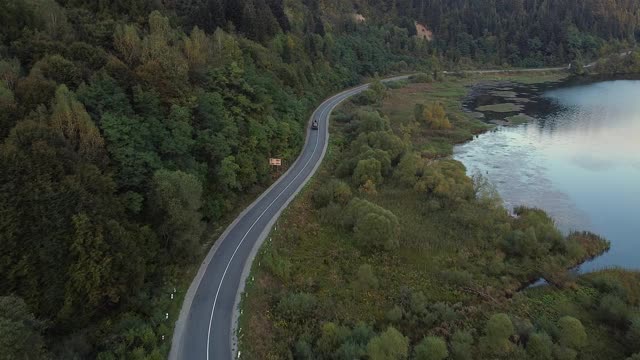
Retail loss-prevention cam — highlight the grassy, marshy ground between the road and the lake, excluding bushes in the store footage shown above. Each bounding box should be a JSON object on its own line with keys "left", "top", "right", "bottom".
{"left": 239, "top": 74, "right": 640, "bottom": 359}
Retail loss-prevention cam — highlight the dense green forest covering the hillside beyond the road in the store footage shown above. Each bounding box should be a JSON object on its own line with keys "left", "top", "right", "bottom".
{"left": 0, "top": 0, "right": 638, "bottom": 359}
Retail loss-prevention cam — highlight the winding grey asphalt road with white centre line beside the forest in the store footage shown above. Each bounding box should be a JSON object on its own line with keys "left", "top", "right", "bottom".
{"left": 169, "top": 75, "right": 408, "bottom": 360}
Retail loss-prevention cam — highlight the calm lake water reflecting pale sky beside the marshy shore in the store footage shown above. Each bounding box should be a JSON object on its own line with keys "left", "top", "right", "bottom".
{"left": 454, "top": 80, "right": 640, "bottom": 271}
